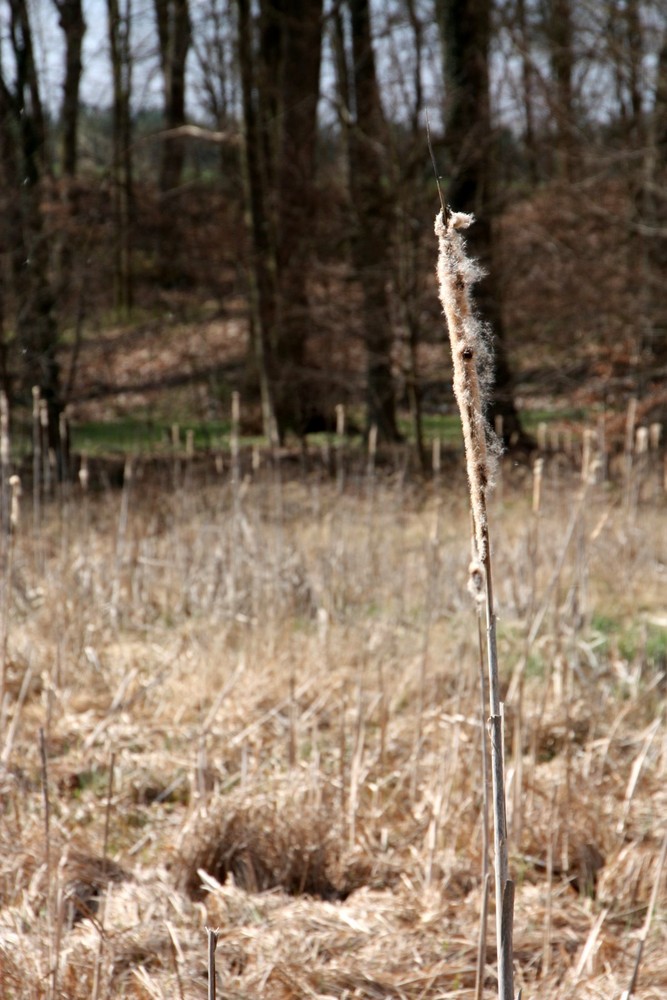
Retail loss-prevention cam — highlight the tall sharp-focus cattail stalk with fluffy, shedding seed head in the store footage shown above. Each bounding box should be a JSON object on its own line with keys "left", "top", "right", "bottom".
{"left": 435, "top": 210, "right": 514, "bottom": 1000}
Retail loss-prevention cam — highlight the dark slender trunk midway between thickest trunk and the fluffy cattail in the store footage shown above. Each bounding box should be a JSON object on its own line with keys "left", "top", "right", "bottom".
{"left": 348, "top": 0, "right": 401, "bottom": 441}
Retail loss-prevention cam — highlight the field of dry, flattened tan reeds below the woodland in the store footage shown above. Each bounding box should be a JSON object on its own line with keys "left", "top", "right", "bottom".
{"left": 0, "top": 456, "right": 667, "bottom": 1000}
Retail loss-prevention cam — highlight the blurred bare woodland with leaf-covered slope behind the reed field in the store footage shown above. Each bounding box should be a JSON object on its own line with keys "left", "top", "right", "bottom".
{"left": 0, "top": 0, "right": 667, "bottom": 462}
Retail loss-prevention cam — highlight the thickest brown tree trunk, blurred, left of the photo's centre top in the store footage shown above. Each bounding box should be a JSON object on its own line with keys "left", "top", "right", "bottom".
{"left": 237, "top": 0, "right": 322, "bottom": 440}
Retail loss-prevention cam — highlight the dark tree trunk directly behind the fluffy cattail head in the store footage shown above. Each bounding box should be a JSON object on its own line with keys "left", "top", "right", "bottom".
{"left": 437, "top": 0, "right": 522, "bottom": 443}
